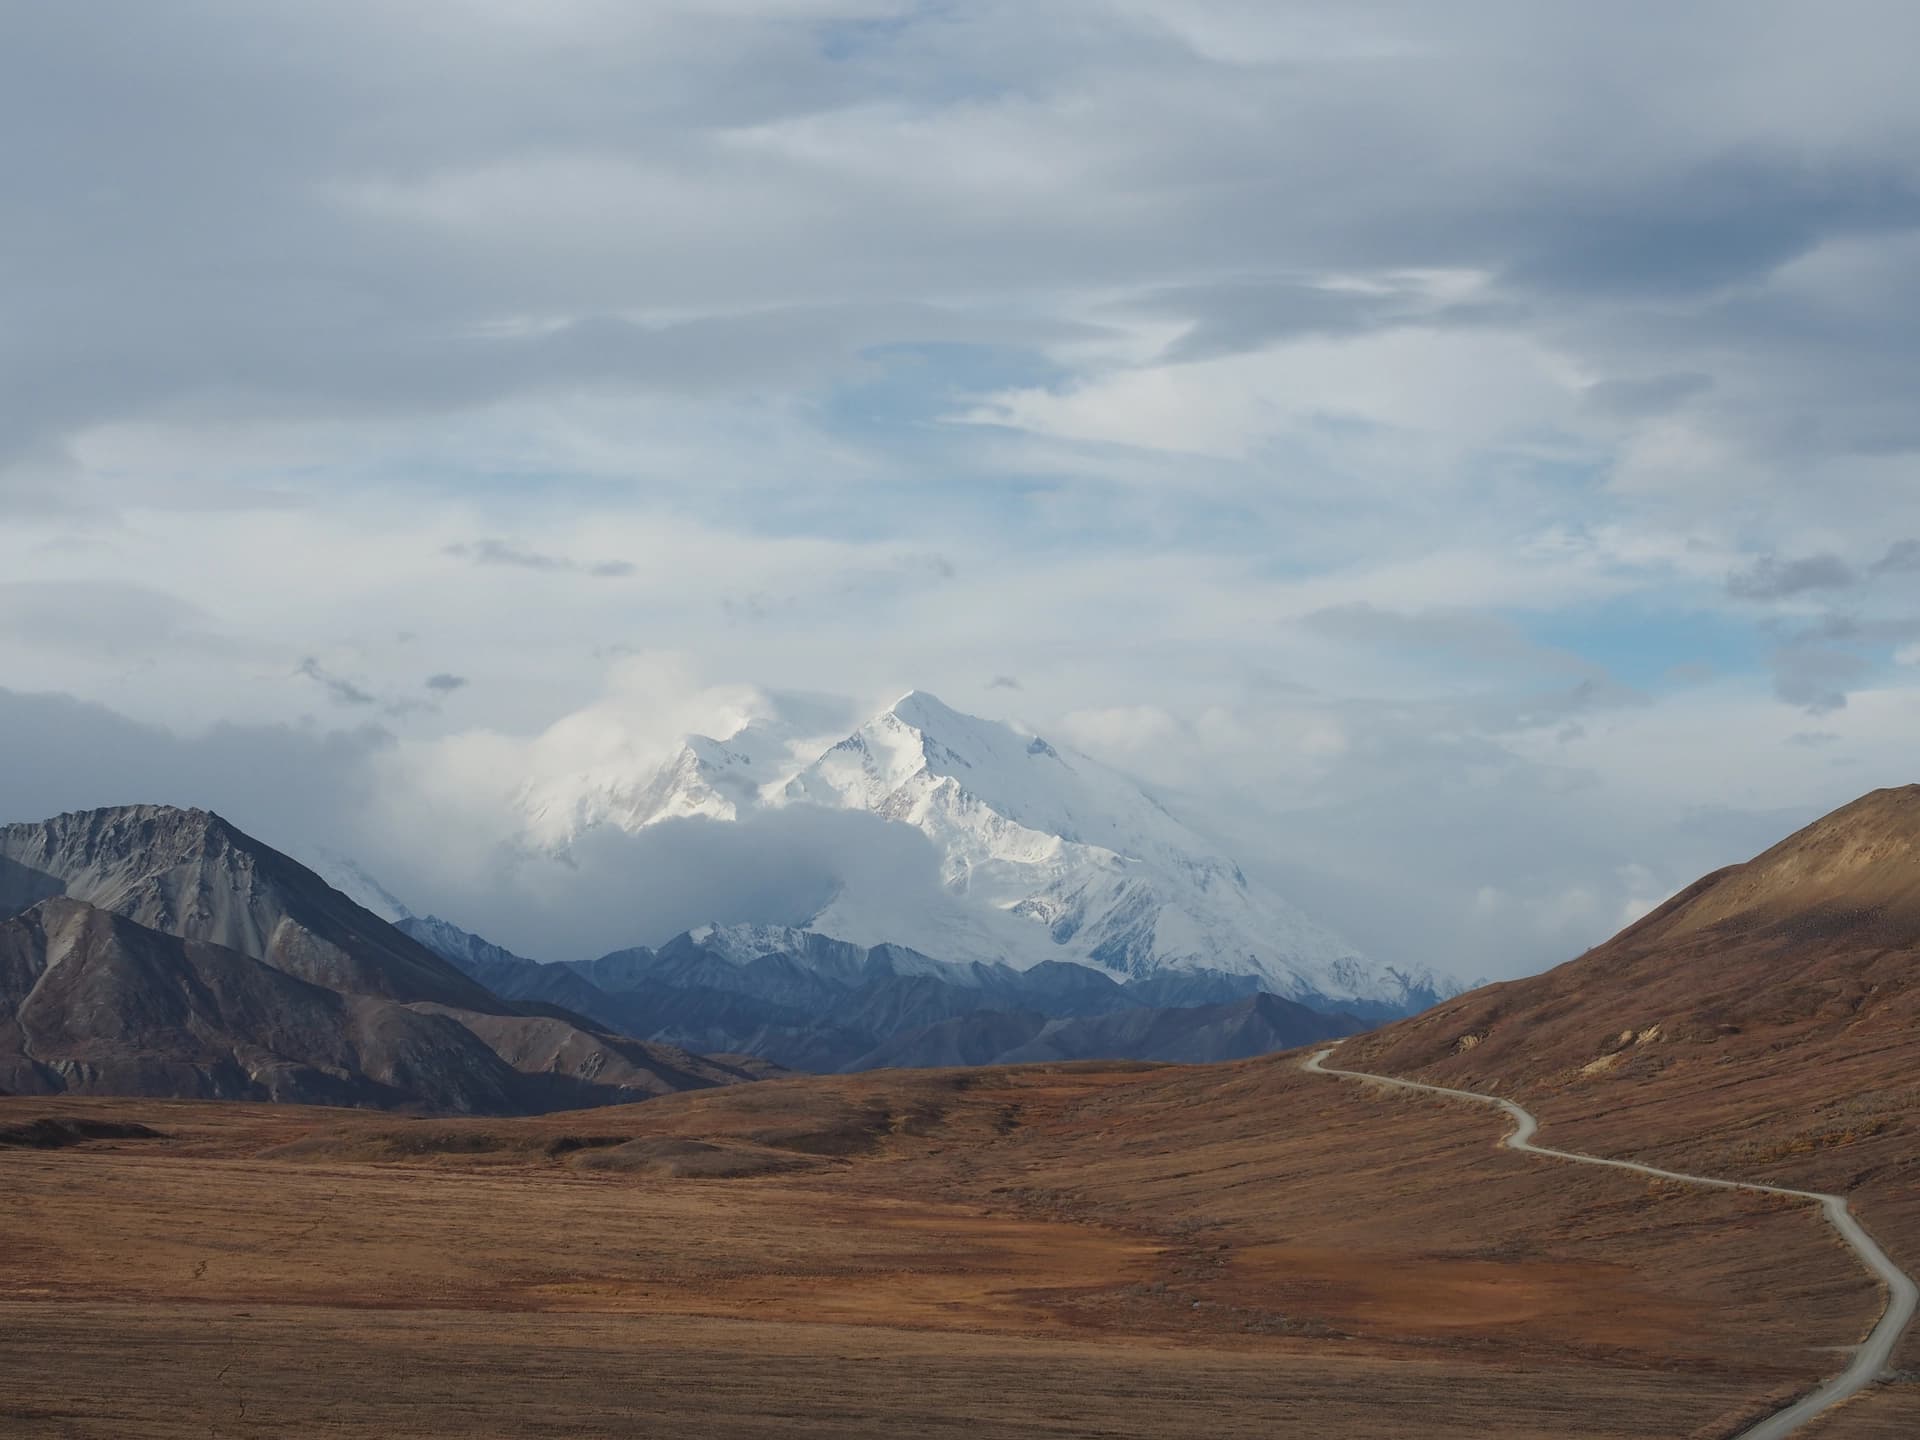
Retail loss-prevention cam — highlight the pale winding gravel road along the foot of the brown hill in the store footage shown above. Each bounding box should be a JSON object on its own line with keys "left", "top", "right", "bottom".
{"left": 1302, "top": 1048, "right": 1920, "bottom": 1440}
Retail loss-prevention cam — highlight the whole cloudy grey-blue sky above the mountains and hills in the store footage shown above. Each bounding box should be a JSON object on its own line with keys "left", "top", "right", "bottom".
{"left": 0, "top": 0, "right": 1920, "bottom": 975}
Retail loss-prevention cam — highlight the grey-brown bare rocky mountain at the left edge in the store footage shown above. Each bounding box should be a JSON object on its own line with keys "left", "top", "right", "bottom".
{"left": 0, "top": 806, "right": 758, "bottom": 1114}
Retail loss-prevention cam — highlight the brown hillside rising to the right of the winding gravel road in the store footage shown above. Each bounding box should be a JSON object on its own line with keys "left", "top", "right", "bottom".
{"left": 1336, "top": 785, "right": 1920, "bottom": 1390}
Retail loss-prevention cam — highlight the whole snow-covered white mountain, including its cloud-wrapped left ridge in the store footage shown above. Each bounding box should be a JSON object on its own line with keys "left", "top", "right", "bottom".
{"left": 522, "top": 691, "right": 1457, "bottom": 1014}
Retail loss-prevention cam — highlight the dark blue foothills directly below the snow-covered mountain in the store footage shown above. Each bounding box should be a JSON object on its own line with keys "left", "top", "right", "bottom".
{"left": 401, "top": 918, "right": 1361, "bottom": 1071}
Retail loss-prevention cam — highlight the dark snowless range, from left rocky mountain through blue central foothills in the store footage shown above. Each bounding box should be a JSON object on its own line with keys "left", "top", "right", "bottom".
{"left": 0, "top": 806, "right": 1382, "bottom": 1114}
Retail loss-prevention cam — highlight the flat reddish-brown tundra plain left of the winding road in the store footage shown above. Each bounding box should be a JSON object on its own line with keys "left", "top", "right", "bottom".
{"left": 0, "top": 1054, "right": 1920, "bottom": 1440}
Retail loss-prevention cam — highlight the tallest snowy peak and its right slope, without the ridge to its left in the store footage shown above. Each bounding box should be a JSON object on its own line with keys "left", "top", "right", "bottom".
{"left": 783, "top": 689, "right": 1444, "bottom": 1012}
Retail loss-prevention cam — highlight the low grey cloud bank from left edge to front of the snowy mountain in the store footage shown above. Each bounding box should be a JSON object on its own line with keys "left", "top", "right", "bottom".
{"left": 0, "top": 689, "right": 939, "bottom": 971}
